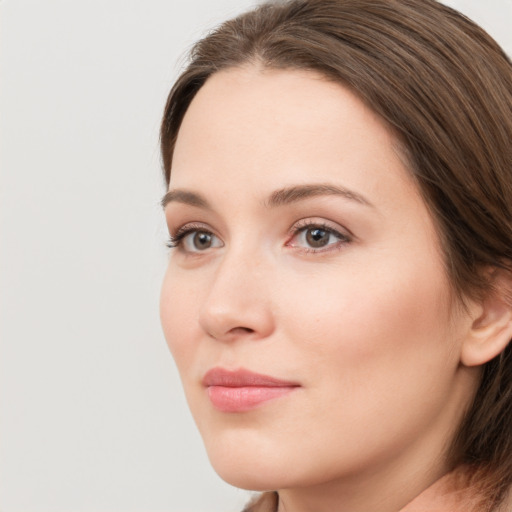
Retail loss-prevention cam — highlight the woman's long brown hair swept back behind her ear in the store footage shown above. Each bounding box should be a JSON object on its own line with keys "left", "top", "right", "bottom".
{"left": 161, "top": 0, "right": 512, "bottom": 510}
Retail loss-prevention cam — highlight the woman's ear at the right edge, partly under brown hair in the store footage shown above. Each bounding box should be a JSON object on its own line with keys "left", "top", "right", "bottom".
{"left": 461, "top": 269, "right": 512, "bottom": 366}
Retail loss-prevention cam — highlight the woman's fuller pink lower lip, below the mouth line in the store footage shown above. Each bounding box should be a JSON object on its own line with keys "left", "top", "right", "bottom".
{"left": 208, "top": 386, "right": 297, "bottom": 412}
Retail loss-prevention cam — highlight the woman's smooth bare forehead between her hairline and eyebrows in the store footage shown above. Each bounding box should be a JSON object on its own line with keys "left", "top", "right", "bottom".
{"left": 170, "top": 67, "right": 417, "bottom": 212}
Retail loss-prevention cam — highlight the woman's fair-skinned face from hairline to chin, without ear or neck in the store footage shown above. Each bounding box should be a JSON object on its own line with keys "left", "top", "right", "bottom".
{"left": 161, "top": 67, "right": 473, "bottom": 489}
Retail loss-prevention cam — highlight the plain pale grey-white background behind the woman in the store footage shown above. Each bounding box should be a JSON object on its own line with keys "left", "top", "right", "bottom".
{"left": 0, "top": 0, "right": 512, "bottom": 512}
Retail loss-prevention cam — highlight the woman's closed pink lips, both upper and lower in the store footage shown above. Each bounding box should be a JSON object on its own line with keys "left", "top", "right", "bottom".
{"left": 203, "top": 368, "right": 299, "bottom": 412}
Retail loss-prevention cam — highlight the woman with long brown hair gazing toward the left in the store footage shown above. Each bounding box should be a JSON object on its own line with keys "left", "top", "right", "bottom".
{"left": 161, "top": 0, "right": 512, "bottom": 512}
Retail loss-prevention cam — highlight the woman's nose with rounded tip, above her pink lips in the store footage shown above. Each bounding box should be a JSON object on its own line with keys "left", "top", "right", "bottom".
{"left": 199, "top": 249, "right": 275, "bottom": 342}
